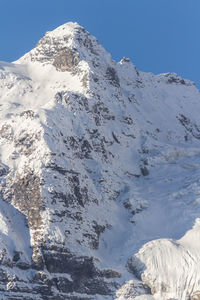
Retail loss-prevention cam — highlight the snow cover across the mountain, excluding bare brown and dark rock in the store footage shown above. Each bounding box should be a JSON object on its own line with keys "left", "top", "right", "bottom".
{"left": 0, "top": 23, "right": 200, "bottom": 300}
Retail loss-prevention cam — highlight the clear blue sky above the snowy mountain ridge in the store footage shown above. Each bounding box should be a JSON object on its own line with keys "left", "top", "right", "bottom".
{"left": 0, "top": 0, "right": 200, "bottom": 87}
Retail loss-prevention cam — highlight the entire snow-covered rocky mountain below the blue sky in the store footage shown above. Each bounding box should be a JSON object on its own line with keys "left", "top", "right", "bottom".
{"left": 0, "top": 23, "right": 200, "bottom": 300}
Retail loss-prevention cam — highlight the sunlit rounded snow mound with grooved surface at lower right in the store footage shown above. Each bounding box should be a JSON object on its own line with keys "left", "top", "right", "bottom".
{"left": 126, "top": 219, "right": 200, "bottom": 300}
